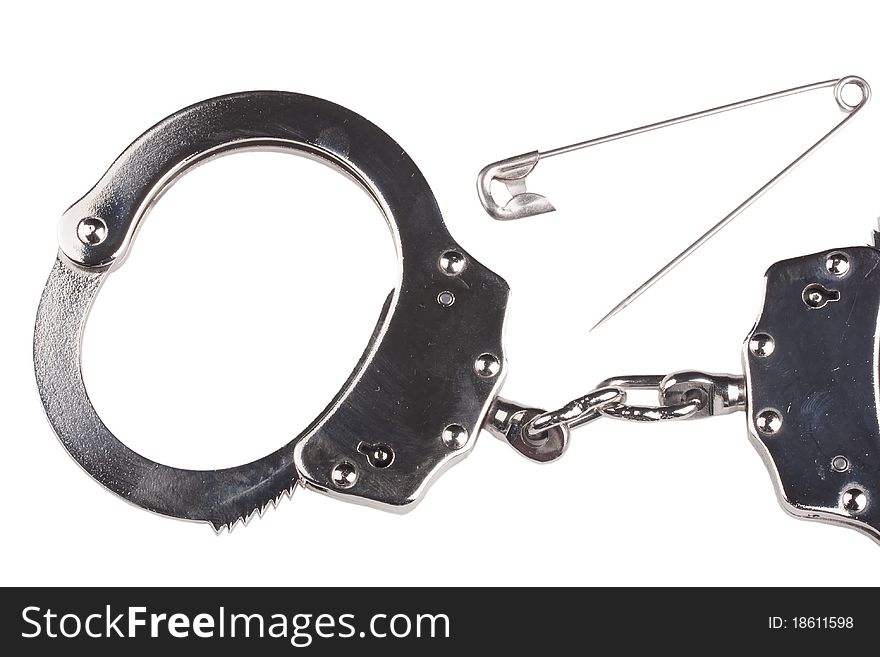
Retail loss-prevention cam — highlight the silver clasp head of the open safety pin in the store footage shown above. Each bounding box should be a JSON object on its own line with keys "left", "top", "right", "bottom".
{"left": 477, "top": 151, "right": 556, "bottom": 221}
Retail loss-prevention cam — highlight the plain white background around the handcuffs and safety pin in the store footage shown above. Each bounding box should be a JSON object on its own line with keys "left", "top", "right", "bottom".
{"left": 0, "top": 0, "right": 880, "bottom": 586}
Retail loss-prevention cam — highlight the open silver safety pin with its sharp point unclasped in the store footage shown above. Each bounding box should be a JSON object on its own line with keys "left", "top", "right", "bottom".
{"left": 477, "top": 75, "right": 871, "bottom": 330}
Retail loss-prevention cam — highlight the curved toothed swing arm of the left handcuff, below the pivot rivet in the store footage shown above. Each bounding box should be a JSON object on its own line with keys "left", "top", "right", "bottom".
{"left": 34, "top": 258, "right": 297, "bottom": 531}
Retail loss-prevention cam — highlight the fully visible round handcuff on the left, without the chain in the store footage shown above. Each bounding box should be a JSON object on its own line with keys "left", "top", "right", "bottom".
{"left": 34, "top": 92, "right": 508, "bottom": 529}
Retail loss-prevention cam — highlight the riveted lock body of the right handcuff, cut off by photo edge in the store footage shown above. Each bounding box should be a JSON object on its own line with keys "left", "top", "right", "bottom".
{"left": 743, "top": 247, "right": 880, "bottom": 542}
